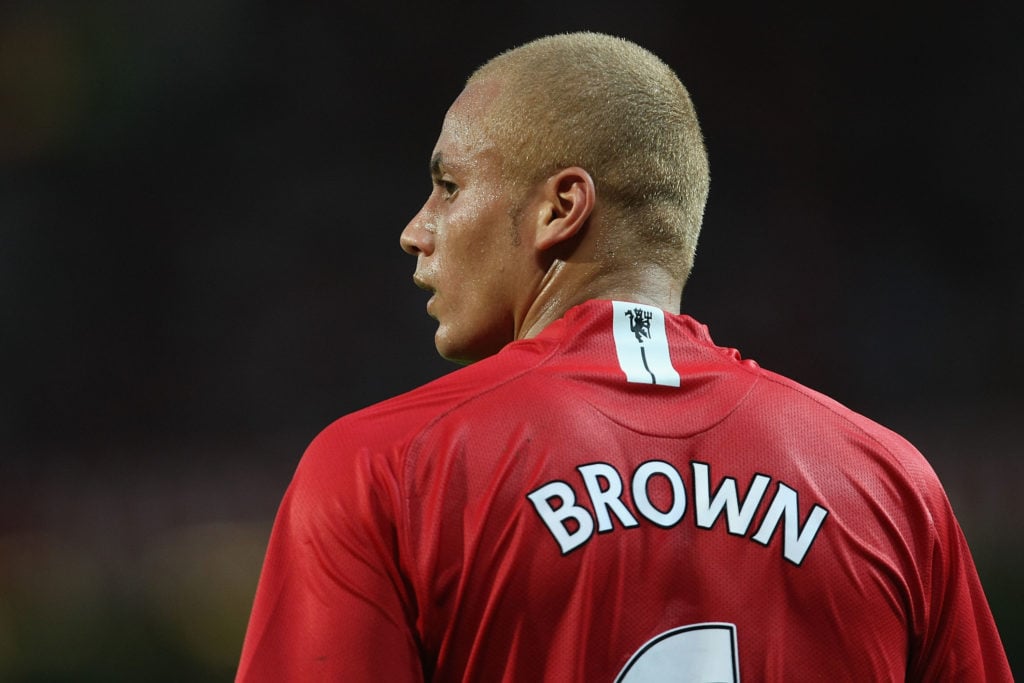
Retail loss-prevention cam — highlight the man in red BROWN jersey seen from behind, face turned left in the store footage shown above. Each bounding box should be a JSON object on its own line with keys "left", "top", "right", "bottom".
{"left": 239, "top": 34, "right": 1011, "bottom": 683}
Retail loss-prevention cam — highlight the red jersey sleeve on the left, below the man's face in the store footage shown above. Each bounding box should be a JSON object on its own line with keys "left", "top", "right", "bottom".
{"left": 237, "top": 428, "right": 423, "bottom": 682}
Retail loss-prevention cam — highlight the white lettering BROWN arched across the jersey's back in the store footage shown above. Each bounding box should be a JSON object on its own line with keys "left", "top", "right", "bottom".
{"left": 526, "top": 460, "right": 828, "bottom": 566}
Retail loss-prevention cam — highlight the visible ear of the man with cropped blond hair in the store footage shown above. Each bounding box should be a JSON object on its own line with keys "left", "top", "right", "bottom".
{"left": 534, "top": 166, "right": 597, "bottom": 251}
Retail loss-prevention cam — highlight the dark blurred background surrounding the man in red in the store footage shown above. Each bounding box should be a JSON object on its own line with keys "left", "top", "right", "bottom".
{"left": 0, "top": 0, "right": 1024, "bottom": 681}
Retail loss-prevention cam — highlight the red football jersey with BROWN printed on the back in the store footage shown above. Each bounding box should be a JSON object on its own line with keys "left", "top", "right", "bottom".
{"left": 238, "top": 301, "right": 1012, "bottom": 683}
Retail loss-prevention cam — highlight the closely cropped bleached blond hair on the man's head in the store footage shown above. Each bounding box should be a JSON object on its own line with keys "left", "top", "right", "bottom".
{"left": 468, "top": 33, "right": 709, "bottom": 282}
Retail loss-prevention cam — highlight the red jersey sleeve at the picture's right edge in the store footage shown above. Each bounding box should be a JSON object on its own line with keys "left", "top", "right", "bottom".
{"left": 910, "top": 464, "right": 1013, "bottom": 681}
